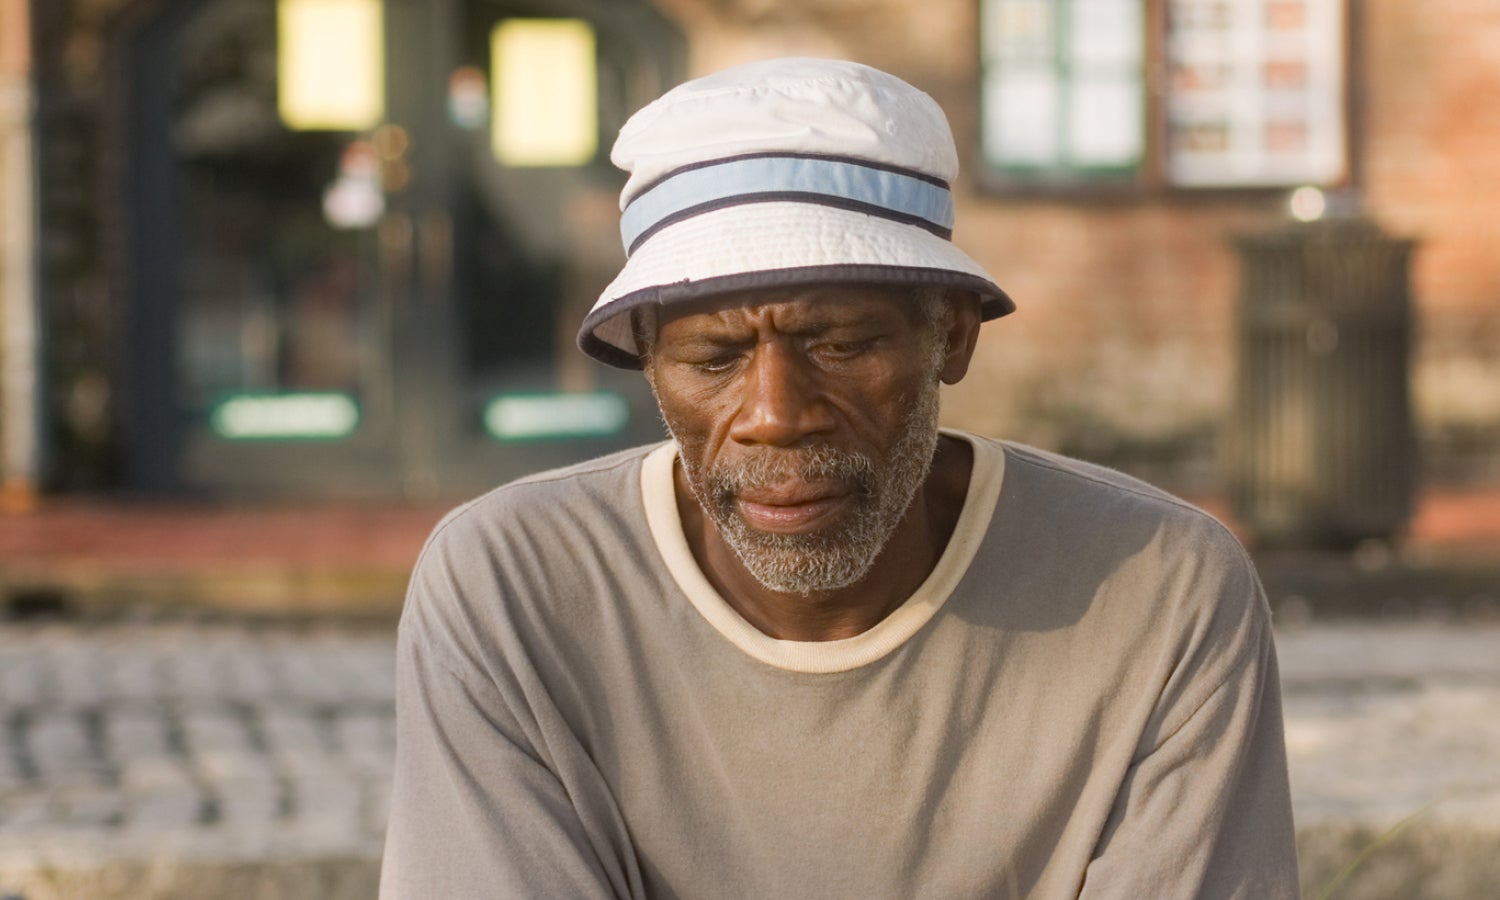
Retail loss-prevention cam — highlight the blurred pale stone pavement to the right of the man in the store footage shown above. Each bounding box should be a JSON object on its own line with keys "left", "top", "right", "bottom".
{"left": 1277, "top": 623, "right": 1500, "bottom": 828}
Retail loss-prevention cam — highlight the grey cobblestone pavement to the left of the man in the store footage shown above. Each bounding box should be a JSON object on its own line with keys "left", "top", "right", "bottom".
{"left": 0, "top": 624, "right": 395, "bottom": 890}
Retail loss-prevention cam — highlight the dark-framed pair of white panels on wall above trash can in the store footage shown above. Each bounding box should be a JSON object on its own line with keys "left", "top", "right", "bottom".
{"left": 980, "top": 0, "right": 1349, "bottom": 188}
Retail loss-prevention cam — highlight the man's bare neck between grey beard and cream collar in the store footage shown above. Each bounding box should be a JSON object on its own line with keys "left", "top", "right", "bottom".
{"left": 674, "top": 437, "right": 974, "bottom": 641}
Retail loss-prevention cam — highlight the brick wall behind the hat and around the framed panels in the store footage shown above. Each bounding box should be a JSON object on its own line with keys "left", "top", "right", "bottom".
{"left": 659, "top": 0, "right": 1500, "bottom": 486}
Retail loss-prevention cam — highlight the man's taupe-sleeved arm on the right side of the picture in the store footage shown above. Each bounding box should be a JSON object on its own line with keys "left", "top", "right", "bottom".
{"left": 1080, "top": 546, "right": 1299, "bottom": 900}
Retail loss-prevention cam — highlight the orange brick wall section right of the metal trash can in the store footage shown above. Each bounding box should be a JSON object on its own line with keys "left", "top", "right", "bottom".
{"left": 1361, "top": 0, "right": 1500, "bottom": 476}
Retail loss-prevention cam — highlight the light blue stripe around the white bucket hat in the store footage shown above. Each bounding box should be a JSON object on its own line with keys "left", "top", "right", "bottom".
{"left": 620, "top": 156, "right": 953, "bottom": 254}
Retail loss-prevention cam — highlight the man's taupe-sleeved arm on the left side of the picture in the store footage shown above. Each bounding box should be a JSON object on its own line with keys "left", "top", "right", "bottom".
{"left": 380, "top": 528, "right": 641, "bottom": 900}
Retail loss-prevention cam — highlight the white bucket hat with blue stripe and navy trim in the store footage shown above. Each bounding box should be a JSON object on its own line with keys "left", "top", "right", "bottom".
{"left": 578, "top": 59, "right": 1016, "bottom": 369}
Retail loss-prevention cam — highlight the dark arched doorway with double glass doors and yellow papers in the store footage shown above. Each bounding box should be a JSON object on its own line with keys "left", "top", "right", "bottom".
{"left": 122, "top": 0, "right": 683, "bottom": 497}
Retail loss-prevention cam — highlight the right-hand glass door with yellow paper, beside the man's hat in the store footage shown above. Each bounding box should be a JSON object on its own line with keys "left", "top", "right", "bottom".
{"left": 414, "top": 0, "right": 681, "bottom": 483}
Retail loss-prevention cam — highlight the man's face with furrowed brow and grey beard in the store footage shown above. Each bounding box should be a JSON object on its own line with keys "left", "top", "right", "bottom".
{"left": 647, "top": 285, "right": 947, "bottom": 594}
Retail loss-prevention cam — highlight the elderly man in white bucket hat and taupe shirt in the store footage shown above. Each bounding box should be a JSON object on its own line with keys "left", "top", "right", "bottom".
{"left": 381, "top": 60, "right": 1296, "bottom": 899}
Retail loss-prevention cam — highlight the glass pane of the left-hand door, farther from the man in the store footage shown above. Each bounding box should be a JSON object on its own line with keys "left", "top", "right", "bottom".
{"left": 183, "top": 0, "right": 389, "bottom": 440}
